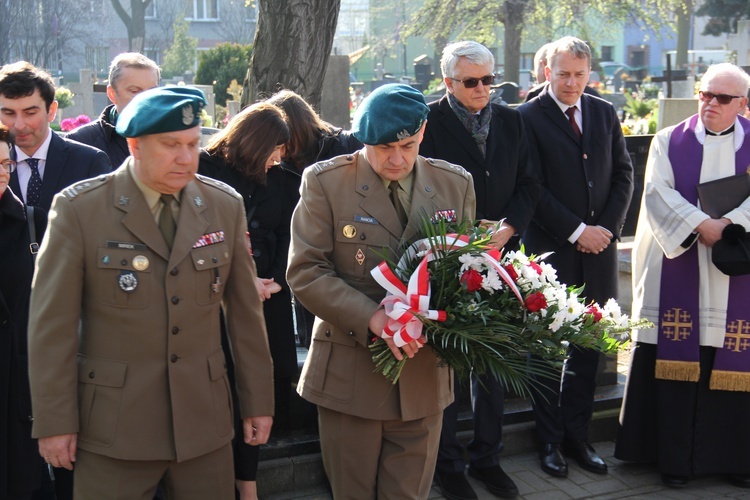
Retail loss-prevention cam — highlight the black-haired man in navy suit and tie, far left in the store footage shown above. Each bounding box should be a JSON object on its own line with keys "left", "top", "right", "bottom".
{"left": 0, "top": 61, "right": 112, "bottom": 229}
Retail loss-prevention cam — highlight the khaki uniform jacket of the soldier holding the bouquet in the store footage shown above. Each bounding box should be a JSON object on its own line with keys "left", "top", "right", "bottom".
{"left": 287, "top": 152, "right": 475, "bottom": 420}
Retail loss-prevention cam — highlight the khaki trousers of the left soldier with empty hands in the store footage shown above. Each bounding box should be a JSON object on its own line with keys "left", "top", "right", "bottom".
{"left": 73, "top": 443, "right": 234, "bottom": 500}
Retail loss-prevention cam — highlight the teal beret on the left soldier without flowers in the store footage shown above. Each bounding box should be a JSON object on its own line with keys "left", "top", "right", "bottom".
{"left": 116, "top": 85, "right": 206, "bottom": 137}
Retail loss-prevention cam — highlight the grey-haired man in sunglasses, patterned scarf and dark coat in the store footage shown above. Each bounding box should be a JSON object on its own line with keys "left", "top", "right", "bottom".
{"left": 419, "top": 41, "right": 539, "bottom": 499}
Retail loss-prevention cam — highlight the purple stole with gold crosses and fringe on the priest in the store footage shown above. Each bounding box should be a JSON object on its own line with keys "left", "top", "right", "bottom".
{"left": 656, "top": 115, "right": 750, "bottom": 392}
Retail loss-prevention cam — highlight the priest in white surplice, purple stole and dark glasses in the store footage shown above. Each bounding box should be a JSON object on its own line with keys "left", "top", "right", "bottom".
{"left": 615, "top": 63, "right": 750, "bottom": 488}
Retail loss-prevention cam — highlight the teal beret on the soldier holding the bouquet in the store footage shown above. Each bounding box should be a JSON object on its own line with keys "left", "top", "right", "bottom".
{"left": 352, "top": 83, "right": 429, "bottom": 146}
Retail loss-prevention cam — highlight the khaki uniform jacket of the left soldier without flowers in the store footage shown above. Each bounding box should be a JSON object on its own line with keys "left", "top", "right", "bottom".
{"left": 29, "top": 163, "right": 273, "bottom": 461}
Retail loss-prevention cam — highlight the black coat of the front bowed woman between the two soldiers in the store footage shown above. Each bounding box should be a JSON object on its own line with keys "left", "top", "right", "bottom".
{"left": 198, "top": 151, "right": 298, "bottom": 379}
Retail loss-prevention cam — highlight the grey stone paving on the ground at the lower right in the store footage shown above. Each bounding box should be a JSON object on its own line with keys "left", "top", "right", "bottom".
{"left": 268, "top": 441, "right": 750, "bottom": 500}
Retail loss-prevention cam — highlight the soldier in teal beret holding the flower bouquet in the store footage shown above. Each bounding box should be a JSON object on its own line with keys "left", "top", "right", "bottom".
{"left": 287, "top": 84, "right": 475, "bottom": 498}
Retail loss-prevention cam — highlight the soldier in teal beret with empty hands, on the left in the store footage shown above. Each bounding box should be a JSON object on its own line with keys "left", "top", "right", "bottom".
{"left": 29, "top": 87, "right": 273, "bottom": 500}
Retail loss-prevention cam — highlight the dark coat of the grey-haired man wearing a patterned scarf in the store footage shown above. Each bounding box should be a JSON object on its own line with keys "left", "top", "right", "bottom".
{"left": 419, "top": 95, "right": 539, "bottom": 234}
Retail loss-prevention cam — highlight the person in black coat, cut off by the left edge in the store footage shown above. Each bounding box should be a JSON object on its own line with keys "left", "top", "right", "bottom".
{"left": 0, "top": 125, "right": 47, "bottom": 500}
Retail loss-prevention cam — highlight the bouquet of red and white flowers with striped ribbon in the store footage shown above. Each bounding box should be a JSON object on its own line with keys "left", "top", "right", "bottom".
{"left": 370, "top": 221, "right": 653, "bottom": 395}
